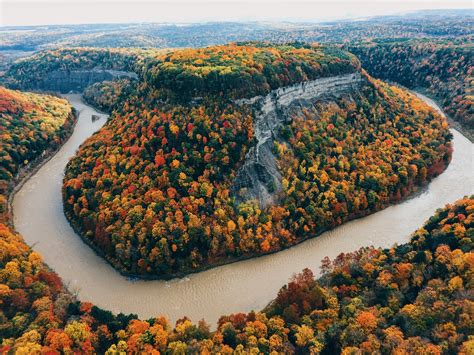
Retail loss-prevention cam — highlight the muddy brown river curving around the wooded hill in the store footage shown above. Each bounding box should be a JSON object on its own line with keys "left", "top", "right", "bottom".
{"left": 13, "top": 95, "right": 474, "bottom": 327}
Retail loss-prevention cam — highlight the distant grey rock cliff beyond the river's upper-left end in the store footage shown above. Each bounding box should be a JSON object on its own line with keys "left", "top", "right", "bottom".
{"left": 26, "top": 69, "right": 137, "bottom": 93}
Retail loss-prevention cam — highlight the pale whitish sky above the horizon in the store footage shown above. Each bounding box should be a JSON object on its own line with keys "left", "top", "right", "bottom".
{"left": 0, "top": 0, "right": 472, "bottom": 26}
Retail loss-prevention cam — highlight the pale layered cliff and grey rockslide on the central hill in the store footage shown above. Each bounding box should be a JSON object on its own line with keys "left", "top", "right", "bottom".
{"left": 232, "top": 73, "right": 363, "bottom": 207}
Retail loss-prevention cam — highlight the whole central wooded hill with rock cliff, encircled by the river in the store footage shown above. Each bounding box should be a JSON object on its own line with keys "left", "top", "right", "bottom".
{"left": 59, "top": 43, "right": 451, "bottom": 278}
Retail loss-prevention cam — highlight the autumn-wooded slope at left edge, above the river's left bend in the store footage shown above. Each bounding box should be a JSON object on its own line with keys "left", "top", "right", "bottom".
{"left": 0, "top": 86, "right": 75, "bottom": 223}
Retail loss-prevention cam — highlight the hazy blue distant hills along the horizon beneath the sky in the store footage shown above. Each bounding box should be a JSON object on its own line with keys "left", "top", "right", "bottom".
{"left": 0, "top": 9, "right": 474, "bottom": 52}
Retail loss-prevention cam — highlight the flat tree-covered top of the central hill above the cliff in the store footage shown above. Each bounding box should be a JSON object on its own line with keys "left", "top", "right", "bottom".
{"left": 145, "top": 43, "right": 359, "bottom": 99}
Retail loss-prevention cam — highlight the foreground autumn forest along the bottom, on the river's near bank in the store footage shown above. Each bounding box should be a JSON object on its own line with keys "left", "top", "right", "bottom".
{"left": 0, "top": 170, "right": 474, "bottom": 355}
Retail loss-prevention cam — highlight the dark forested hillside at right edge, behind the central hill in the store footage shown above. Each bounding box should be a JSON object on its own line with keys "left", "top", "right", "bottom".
{"left": 347, "top": 37, "right": 474, "bottom": 140}
